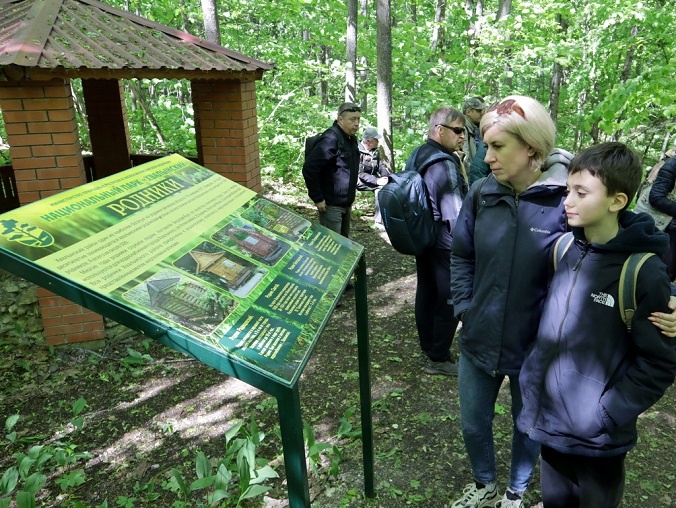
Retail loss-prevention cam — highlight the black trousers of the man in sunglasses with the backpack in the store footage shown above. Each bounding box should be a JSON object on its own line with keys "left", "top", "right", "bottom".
{"left": 415, "top": 247, "right": 458, "bottom": 362}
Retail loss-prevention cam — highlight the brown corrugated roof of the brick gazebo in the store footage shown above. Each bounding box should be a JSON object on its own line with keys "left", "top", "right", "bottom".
{"left": 0, "top": 0, "right": 273, "bottom": 81}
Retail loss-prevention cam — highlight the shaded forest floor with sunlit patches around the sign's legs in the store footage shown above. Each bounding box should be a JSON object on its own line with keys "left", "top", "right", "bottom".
{"left": 0, "top": 185, "right": 676, "bottom": 508}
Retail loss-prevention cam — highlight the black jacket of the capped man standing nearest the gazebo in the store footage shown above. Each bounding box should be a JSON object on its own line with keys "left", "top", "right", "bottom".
{"left": 303, "top": 121, "right": 359, "bottom": 207}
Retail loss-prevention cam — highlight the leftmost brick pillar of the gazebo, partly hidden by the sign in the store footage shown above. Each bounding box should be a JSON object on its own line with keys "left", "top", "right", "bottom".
{"left": 0, "top": 79, "right": 104, "bottom": 345}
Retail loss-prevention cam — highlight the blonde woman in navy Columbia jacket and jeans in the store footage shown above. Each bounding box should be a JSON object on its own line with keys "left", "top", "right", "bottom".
{"left": 451, "top": 95, "right": 566, "bottom": 508}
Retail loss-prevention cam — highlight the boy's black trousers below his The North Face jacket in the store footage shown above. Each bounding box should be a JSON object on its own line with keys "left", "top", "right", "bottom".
{"left": 540, "top": 445, "right": 627, "bottom": 508}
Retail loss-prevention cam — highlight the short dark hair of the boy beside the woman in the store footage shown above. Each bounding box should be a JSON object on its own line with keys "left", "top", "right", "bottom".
{"left": 568, "top": 142, "right": 643, "bottom": 208}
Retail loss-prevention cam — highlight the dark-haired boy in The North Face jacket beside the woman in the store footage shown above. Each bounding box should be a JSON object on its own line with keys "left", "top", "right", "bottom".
{"left": 517, "top": 143, "right": 676, "bottom": 508}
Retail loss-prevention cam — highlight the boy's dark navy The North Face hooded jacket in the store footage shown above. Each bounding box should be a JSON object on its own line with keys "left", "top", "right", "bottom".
{"left": 517, "top": 212, "right": 676, "bottom": 457}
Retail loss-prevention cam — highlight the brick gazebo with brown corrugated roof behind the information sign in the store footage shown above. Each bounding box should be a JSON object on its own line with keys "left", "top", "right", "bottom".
{"left": 0, "top": 0, "right": 272, "bottom": 344}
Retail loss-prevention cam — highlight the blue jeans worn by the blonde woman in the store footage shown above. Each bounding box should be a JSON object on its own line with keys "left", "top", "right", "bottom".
{"left": 458, "top": 354, "right": 540, "bottom": 494}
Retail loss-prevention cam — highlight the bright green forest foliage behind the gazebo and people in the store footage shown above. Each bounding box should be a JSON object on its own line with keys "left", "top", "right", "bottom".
{"left": 0, "top": 0, "right": 676, "bottom": 179}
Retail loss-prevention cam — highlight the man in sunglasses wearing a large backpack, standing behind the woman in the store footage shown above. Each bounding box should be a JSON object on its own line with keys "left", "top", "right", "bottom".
{"left": 414, "top": 106, "right": 467, "bottom": 376}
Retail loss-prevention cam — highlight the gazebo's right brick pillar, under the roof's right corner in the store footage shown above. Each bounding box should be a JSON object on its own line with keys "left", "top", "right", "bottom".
{"left": 191, "top": 80, "right": 261, "bottom": 191}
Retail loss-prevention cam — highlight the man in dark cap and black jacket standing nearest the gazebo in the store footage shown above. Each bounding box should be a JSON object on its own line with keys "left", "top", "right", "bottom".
{"left": 303, "top": 102, "right": 361, "bottom": 237}
